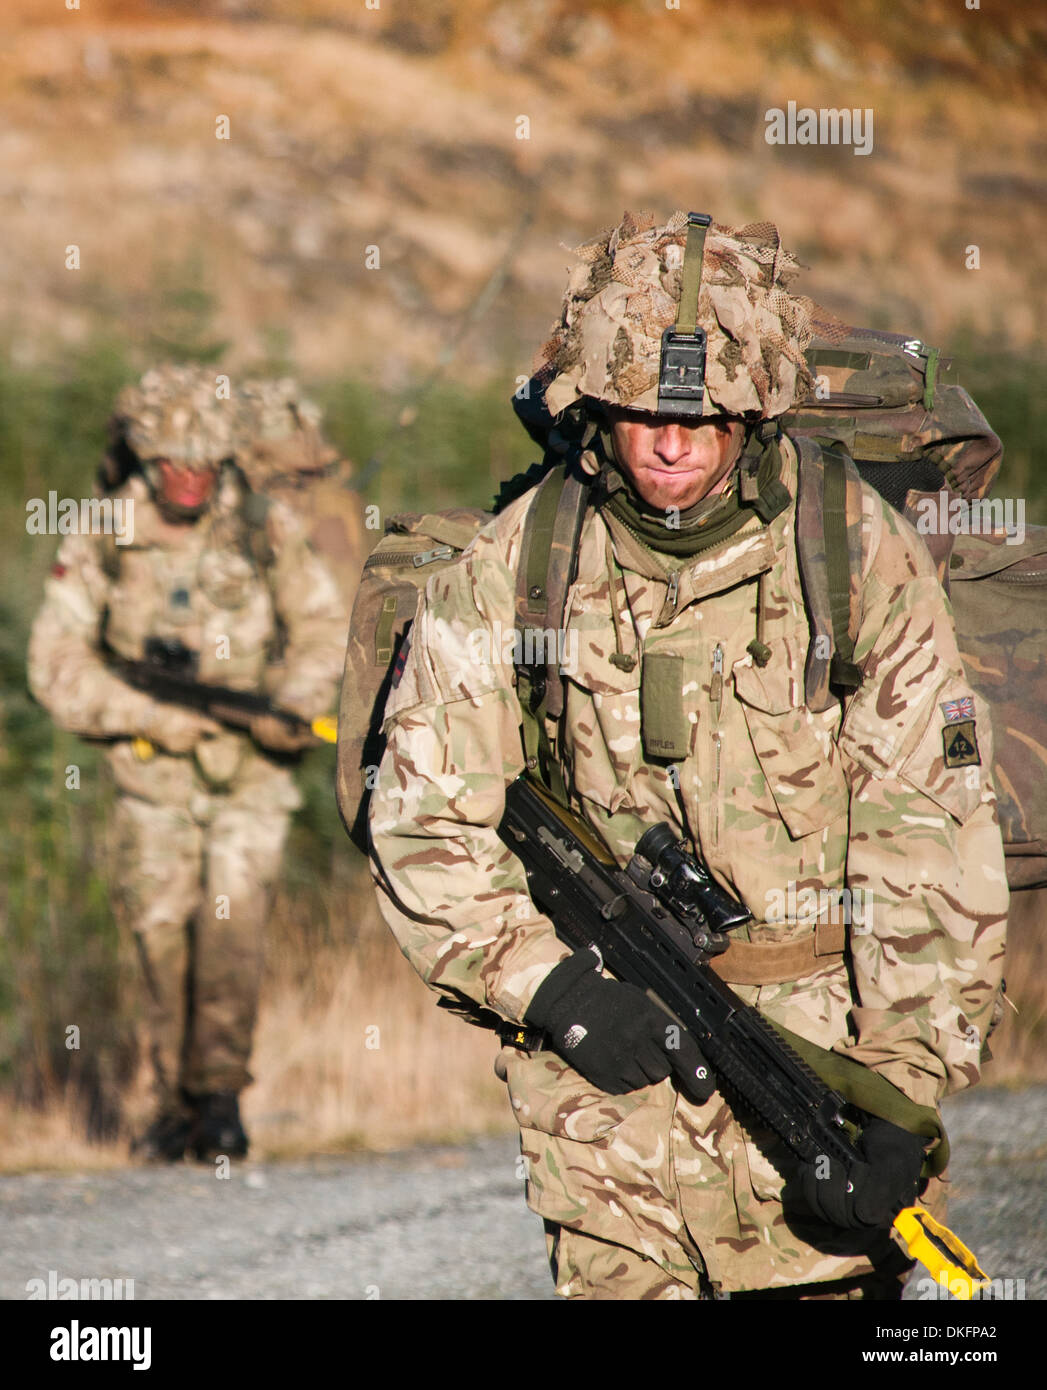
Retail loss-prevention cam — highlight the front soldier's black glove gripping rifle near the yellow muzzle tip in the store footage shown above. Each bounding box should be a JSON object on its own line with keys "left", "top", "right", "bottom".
{"left": 801, "top": 1119, "right": 923, "bottom": 1230}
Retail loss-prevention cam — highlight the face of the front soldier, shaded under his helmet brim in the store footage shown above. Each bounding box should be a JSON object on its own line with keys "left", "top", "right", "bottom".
{"left": 606, "top": 406, "right": 745, "bottom": 512}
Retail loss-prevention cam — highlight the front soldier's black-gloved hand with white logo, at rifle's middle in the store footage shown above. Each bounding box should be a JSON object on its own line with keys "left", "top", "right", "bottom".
{"left": 527, "top": 951, "right": 716, "bottom": 1105}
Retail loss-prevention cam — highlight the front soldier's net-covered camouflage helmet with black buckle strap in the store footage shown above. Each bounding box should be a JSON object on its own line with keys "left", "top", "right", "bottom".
{"left": 539, "top": 213, "right": 811, "bottom": 420}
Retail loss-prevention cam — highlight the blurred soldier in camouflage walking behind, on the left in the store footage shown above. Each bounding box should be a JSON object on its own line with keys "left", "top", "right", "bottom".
{"left": 29, "top": 367, "right": 346, "bottom": 1161}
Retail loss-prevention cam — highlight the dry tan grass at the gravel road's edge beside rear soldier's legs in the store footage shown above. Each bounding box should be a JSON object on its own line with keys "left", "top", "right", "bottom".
{"left": 0, "top": 891, "right": 513, "bottom": 1172}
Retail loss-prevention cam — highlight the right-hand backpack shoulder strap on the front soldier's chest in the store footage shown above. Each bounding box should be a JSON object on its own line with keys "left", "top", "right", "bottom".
{"left": 794, "top": 436, "right": 862, "bottom": 712}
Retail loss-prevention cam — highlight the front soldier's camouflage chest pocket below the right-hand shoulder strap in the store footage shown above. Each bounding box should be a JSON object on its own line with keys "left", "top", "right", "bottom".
{"left": 733, "top": 637, "right": 848, "bottom": 840}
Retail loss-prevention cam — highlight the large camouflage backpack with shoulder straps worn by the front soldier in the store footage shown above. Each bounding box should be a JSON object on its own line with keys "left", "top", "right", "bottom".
{"left": 336, "top": 321, "right": 1047, "bottom": 888}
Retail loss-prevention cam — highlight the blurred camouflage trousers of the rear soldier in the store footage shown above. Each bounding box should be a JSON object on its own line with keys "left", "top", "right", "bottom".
{"left": 111, "top": 795, "right": 289, "bottom": 1109}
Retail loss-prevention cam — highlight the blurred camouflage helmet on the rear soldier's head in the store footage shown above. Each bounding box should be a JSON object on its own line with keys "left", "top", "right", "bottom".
{"left": 113, "top": 364, "right": 235, "bottom": 475}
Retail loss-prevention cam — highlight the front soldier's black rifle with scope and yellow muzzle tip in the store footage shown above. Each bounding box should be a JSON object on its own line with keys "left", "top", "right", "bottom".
{"left": 499, "top": 777, "right": 987, "bottom": 1298}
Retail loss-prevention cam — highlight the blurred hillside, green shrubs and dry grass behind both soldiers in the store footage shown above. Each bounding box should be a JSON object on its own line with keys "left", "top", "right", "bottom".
{"left": 0, "top": 0, "right": 1047, "bottom": 1166}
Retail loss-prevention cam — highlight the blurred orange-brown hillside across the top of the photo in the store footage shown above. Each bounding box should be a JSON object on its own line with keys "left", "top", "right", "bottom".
{"left": 0, "top": 0, "right": 1047, "bottom": 388}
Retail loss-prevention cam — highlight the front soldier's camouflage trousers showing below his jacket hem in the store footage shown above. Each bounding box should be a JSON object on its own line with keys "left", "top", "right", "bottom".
{"left": 545, "top": 1220, "right": 914, "bottom": 1302}
